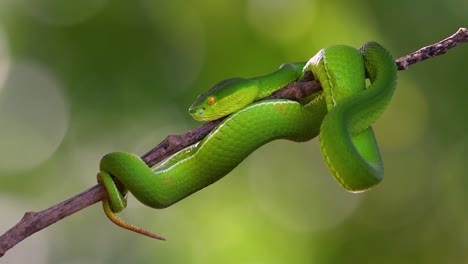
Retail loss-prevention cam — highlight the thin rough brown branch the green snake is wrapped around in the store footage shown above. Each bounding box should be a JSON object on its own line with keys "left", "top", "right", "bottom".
{"left": 0, "top": 28, "right": 468, "bottom": 257}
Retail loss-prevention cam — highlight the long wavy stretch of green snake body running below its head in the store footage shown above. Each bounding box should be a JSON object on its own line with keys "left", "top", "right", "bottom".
{"left": 100, "top": 100, "right": 326, "bottom": 211}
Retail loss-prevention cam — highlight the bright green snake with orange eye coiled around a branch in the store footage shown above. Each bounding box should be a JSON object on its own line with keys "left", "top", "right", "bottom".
{"left": 97, "top": 42, "right": 397, "bottom": 239}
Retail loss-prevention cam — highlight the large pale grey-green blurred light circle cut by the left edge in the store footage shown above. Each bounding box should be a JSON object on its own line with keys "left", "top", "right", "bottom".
{"left": 0, "top": 62, "right": 69, "bottom": 173}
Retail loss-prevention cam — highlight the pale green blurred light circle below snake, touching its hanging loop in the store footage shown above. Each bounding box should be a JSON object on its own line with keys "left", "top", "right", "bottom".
{"left": 248, "top": 140, "right": 361, "bottom": 233}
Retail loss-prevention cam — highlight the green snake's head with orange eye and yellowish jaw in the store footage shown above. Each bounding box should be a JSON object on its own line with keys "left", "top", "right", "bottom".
{"left": 189, "top": 78, "right": 257, "bottom": 121}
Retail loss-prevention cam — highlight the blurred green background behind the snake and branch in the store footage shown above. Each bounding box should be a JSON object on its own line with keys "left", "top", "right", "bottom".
{"left": 0, "top": 0, "right": 468, "bottom": 264}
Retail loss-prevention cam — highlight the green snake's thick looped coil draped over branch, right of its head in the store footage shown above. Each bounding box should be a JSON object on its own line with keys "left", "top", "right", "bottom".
{"left": 305, "top": 42, "right": 397, "bottom": 192}
